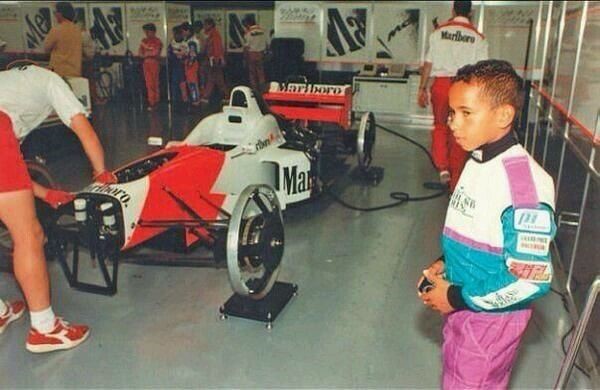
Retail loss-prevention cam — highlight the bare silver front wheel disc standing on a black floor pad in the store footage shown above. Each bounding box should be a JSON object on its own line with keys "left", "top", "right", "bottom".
{"left": 227, "top": 185, "right": 284, "bottom": 300}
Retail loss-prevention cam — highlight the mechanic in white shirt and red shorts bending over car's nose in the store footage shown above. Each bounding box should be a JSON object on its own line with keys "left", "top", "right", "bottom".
{"left": 0, "top": 65, "right": 116, "bottom": 352}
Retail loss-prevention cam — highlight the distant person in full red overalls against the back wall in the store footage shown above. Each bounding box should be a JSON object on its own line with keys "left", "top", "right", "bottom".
{"left": 139, "top": 23, "right": 162, "bottom": 111}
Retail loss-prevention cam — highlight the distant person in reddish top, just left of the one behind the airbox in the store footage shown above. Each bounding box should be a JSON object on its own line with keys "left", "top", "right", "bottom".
{"left": 203, "top": 18, "right": 229, "bottom": 106}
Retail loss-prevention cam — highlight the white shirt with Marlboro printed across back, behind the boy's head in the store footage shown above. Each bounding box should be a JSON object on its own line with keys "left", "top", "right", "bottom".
{"left": 425, "top": 16, "right": 488, "bottom": 77}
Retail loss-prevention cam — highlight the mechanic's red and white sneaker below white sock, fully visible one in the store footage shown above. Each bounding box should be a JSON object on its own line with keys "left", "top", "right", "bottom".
{"left": 25, "top": 317, "right": 90, "bottom": 353}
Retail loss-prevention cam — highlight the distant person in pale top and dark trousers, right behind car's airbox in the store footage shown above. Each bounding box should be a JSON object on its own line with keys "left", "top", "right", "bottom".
{"left": 242, "top": 14, "right": 267, "bottom": 94}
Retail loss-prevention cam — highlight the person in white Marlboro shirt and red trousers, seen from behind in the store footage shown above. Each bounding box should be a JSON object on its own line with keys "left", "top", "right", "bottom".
{"left": 418, "top": 1, "right": 488, "bottom": 191}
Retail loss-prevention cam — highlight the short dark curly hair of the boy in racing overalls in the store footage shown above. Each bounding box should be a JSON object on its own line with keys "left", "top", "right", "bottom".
{"left": 452, "top": 60, "right": 523, "bottom": 112}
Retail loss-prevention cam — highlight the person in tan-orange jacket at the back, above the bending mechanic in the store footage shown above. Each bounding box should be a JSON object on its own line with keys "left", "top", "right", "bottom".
{"left": 44, "top": 1, "right": 83, "bottom": 77}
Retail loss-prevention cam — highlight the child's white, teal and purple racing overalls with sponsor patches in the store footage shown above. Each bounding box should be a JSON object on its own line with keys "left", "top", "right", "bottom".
{"left": 442, "top": 134, "right": 556, "bottom": 389}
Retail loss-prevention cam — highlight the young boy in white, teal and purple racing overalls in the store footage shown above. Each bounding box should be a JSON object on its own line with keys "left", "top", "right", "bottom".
{"left": 419, "top": 60, "right": 556, "bottom": 389}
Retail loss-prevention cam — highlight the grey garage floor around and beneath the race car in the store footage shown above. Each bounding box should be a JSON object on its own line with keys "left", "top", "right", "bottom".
{"left": 0, "top": 104, "right": 590, "bottom": 388}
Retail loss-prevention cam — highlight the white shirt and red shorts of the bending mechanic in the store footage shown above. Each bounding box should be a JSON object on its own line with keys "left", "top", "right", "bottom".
{"left": 0, "top": 65, "right": 86, "bottom": 192}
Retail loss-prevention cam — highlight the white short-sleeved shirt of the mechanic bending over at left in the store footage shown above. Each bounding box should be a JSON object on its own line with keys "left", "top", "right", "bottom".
{"left": 0, "top": 65, "right": 87, "bottom": 140}
